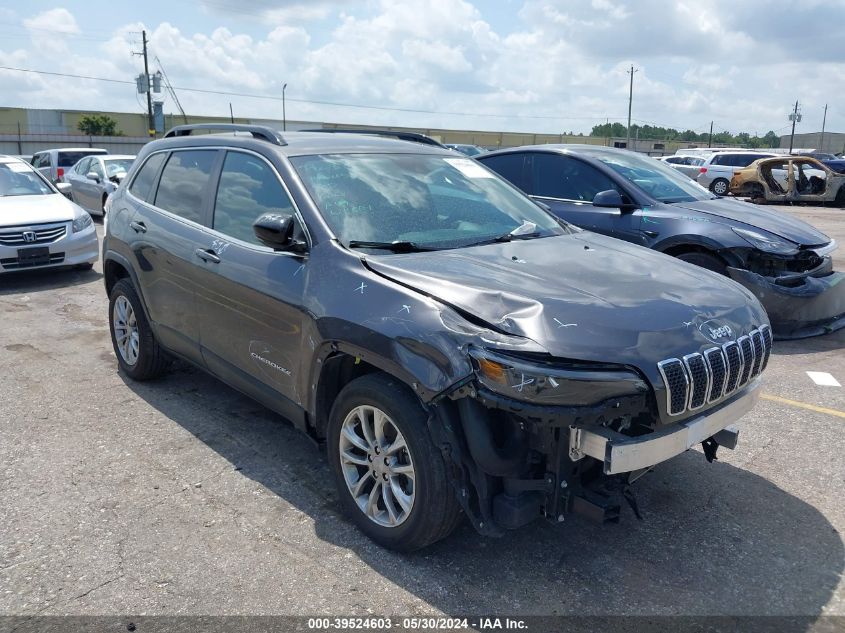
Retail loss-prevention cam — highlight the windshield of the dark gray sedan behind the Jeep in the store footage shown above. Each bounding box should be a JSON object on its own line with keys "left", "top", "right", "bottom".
{"left": 578, "top": 149, "right": 715, "bottom": 203}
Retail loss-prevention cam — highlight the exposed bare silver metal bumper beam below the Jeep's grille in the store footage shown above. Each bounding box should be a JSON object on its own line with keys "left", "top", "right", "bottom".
{"left": 569, "top": 379, "right": 760, "bottom": 475}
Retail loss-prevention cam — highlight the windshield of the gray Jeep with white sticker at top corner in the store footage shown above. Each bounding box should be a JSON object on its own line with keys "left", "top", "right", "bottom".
{"left": 291, "top": 154, "right": 567, "bottom": 248}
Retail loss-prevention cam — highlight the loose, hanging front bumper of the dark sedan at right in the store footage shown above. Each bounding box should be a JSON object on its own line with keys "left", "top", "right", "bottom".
{"left": 728, "top": 257, "right": 845, "bottom": 340}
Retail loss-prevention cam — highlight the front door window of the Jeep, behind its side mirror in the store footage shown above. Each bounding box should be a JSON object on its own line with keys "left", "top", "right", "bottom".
{"left": 212, "top": 152, "right": 294, "bottom": 244}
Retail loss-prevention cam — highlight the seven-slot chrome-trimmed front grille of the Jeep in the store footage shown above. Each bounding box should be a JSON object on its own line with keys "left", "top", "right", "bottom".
{"left": 657, "top": 325, "right": 772, "bottom": 415}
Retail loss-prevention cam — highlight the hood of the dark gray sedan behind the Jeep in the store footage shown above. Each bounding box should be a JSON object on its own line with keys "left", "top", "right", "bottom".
{"left": 672, "top": 198, "right": 830, "bottom": 246}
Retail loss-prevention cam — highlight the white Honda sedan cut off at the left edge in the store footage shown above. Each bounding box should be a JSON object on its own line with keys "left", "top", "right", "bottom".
{"left": 0, "top": 155, "right": 99, "bottom": 274}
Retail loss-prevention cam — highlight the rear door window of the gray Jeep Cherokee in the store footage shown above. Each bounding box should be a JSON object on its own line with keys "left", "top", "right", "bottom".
{"left": 155, "top": 150, "right": 217, "bottom": 222}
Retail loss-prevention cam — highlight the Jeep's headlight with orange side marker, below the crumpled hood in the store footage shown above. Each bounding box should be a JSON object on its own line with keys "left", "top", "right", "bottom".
{"left": 469, "top": 348, "right": 648, "bottom": 406}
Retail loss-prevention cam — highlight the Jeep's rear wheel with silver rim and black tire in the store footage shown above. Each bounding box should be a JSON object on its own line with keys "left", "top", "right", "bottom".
{"left": 109, "top": 279, "right": 168, "bottom": 381}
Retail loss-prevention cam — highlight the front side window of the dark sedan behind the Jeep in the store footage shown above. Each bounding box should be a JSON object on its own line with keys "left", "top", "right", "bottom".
{"left": 531, "top": 154, "right": 616, "bottom": 202}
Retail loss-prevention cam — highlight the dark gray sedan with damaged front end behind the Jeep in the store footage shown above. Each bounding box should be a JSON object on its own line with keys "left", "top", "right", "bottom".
{"left": 476, "top": 145, "right": 845, "bottom": 338}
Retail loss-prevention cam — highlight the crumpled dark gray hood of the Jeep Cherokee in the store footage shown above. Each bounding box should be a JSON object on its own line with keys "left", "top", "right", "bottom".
{"left": 366, "top": 232, "right": 768, "bottom": 367}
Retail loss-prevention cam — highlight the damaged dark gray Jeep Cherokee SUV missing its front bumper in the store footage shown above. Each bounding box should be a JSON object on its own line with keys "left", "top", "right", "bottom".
{"left": 103, "top": 126, "right": 772, "bottom": 551}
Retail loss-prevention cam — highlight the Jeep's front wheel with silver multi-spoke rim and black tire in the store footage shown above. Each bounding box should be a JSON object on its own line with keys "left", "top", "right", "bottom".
{"left": 327, "top": 374, "right": 461, "bottom": 552}
